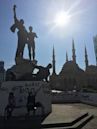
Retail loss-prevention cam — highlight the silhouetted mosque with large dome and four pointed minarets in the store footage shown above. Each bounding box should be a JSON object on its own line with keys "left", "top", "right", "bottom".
{"left": 50, "top": 40, "right": 97, "bottom": 91}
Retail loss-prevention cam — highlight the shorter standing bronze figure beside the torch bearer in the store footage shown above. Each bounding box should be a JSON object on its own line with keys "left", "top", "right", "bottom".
{"left": 28, "top": 26, "right": 38, "bottom": 60}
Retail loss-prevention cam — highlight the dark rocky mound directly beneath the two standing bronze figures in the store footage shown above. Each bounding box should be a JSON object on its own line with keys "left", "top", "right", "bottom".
{"left": 6, "top": 58, "right": 37, "bottom": 81}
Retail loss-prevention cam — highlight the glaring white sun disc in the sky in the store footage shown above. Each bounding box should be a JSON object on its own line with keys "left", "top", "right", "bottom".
{"left": 54, "top": 11, "right": 70, "bottom": 26}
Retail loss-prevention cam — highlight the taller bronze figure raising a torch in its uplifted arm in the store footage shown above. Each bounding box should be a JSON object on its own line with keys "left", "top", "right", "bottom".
{"left": 10, "top": 5, "right": 27, "bottom": 59}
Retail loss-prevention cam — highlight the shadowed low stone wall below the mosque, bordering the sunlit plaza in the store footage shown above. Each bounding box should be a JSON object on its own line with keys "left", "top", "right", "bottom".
{"left": 52, "top": 92, "right": 97, "bottom": 106}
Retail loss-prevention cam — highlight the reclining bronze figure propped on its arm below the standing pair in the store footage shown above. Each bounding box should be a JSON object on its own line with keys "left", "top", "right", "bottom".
{"left": 11, "top": 64, "right": 52, "bottom": 82}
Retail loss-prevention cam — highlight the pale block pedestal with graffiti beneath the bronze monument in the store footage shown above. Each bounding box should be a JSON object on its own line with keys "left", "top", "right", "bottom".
{"left": 0, "top": 81, "right": 52, "bottom": 116}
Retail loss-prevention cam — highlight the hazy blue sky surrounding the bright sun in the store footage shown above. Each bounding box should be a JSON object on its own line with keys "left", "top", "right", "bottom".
{"left": 0, "top": 0, "right": 97, "bottom": 73}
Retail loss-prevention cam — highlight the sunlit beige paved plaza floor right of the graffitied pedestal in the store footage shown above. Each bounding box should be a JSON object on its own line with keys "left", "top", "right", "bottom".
{"left": 43, "top": 104, "right": 97, "bottom": 129}
